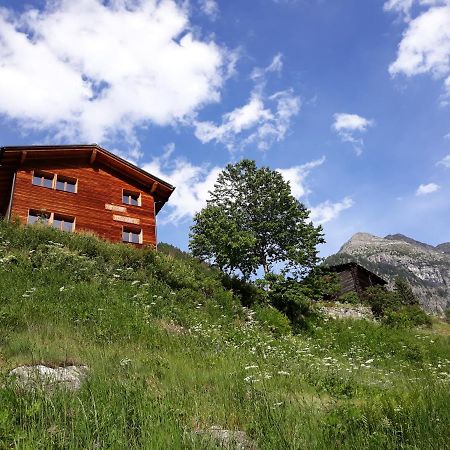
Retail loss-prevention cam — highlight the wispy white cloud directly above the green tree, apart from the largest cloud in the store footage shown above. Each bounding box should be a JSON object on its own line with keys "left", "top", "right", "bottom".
{"left": 194, "top": 90, "right": 300, "bottom": 152}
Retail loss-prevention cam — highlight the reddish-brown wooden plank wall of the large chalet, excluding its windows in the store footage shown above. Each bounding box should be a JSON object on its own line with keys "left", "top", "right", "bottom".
{"left": 11, "top": 163, "right": 156, "bottom": 245}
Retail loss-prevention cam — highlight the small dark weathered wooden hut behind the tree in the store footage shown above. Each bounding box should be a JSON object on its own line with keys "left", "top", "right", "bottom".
{"left": 328, "top": 262, "right": 388, "bottom": 296}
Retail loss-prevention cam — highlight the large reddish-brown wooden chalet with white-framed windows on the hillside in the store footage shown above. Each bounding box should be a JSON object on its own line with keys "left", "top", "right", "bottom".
{"left": 0, "top": 144, "right": 175, "bottom": 245}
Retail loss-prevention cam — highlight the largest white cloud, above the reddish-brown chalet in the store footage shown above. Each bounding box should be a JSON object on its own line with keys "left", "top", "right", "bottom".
{"left": 0, "top": 0, "right": 232, "bottom": 157}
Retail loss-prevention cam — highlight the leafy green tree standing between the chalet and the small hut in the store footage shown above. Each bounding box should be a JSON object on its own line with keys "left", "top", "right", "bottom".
{"left": 189, "top": 160, "right": 324, "bottom": 278}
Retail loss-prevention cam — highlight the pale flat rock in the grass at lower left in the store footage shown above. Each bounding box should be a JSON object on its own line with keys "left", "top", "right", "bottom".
{"left": 9, "top": 364, "right": 89, "bottom": 391}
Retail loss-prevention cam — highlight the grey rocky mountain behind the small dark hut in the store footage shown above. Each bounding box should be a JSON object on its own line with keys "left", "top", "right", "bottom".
{"left": 326, "top": 233, "right": 450, "bottom": 315}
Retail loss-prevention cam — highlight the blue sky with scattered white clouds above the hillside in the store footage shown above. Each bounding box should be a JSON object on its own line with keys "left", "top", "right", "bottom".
{"left": 0, "top": 0, "right": 450, "bottom": 255}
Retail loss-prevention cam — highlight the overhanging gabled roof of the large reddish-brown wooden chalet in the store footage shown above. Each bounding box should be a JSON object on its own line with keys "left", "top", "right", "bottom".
{"left": 0, "top": 144, "right": 175, "bottom": 213}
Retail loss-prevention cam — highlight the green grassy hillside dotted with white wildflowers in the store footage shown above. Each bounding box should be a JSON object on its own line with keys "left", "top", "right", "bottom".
{"left": 0, "top": 223, "right": 450, "bottom": 449}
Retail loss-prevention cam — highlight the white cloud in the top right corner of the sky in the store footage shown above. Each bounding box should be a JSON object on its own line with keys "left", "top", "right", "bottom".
{"left": 385, "top": 0, "right": 450, "bottom": 99}
